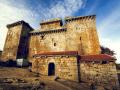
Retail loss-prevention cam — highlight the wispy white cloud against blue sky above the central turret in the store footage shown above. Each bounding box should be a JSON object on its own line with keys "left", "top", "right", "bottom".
{"left": 39, "top": 0, "right": 86, "bottom": 19}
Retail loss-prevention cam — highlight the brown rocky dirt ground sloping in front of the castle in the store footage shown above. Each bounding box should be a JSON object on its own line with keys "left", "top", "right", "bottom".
{"left": 0, "top": 67, "right": 89, "bottom": 90}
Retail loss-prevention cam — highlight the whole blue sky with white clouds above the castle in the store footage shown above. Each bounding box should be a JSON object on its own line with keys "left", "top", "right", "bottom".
{"left": 0, "top": 0, "right": 120, "bottom": 63}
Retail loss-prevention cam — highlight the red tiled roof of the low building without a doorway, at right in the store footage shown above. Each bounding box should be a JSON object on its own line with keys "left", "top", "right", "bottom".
{"left": 80, "top": 54, "right": 116, "bottom": 61}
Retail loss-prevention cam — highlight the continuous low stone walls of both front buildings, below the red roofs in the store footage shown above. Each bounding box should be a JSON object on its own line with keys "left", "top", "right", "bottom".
{"left": 32, "top": 55, "right": 119, "bottom": 88}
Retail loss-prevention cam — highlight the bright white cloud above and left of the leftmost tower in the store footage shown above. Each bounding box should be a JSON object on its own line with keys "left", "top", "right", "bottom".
{"left": 0, "top": 0, "right": 39, "bottom": 50}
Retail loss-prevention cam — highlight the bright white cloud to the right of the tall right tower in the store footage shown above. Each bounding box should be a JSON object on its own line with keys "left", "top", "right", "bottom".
{"left": 98, "top": 7, "right": 120, "bottom": 63}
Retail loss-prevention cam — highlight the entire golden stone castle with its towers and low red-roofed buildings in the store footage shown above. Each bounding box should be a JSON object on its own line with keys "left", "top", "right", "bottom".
{"left": 1, "top": 15, "right": 119, "bottom": 87}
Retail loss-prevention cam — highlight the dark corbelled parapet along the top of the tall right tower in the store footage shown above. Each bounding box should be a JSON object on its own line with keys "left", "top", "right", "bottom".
{"left": 65, "top": 15, "right": 96, "bottom": 22}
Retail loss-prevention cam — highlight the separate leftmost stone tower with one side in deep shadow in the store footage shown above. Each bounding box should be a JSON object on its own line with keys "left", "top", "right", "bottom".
{"left": 2, "top": 21, "right": 33, "bottom": 61}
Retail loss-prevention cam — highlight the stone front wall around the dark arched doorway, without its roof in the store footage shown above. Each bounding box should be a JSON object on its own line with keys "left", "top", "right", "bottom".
{"left": 32, "top": 56, "right": 79, "bottom": 81}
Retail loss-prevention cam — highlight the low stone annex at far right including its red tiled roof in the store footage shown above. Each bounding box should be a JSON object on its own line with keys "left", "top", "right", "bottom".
{"left": 80, "top": 55, "right": 119, "bottom": 87}
